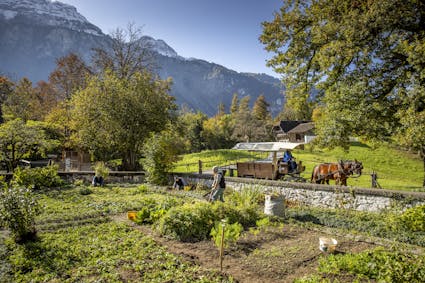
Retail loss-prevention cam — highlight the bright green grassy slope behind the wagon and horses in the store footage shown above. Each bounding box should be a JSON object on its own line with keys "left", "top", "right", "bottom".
{"left": 174, "top": 143, "right": 424, "bottom": 191}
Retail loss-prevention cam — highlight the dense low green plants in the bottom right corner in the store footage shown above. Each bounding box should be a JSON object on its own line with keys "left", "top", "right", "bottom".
{"left": 319, "top": 248, "right": 425, "bottom": 282}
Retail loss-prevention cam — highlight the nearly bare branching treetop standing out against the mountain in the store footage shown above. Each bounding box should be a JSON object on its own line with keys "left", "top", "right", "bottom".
{"left": 92, "top": 24, "right": 155, "bottom": 79}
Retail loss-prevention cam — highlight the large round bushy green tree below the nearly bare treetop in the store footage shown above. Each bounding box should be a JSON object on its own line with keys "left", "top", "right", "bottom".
{"left": 71, "top": 71, "right": 176, "bottom": 170}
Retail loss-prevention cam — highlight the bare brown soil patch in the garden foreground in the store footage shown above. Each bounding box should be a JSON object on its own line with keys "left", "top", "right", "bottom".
{"left": 115, "top": 215, "right": 377, "bottom": 283}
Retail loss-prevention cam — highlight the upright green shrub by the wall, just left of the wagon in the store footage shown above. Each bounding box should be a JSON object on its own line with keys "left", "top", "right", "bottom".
{"left": 142, "top": 129, "right": 180, "bottom": 185}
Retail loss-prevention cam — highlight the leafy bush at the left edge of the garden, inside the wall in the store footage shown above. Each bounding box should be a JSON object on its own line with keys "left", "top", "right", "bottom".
{"left": 0, "top": 185, "right": 41, "bottom": 242}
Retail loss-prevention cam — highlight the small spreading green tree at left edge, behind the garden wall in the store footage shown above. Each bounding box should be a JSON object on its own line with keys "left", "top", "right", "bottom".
{"left": 0, "top": 119, "right": 50, "bottom": 171}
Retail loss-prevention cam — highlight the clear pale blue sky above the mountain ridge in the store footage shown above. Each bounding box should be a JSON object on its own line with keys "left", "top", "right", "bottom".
{"left": 59, "top": 0, "right": 283, "bottom": 78}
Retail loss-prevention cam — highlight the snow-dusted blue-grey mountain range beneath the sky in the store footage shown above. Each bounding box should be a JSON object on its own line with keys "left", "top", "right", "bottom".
{"left": 0, "top": 0, "right": 284, "bottom": 116}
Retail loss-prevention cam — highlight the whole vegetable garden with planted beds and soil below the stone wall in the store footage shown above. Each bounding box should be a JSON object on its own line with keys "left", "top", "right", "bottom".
{"left": 0, "top": 184, "right": 425, "bottom": 282}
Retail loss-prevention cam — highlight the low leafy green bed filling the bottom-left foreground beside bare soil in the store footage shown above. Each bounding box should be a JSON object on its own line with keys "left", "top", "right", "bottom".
{"left": 0, "top": 222, "right": 231, "bottom": 282}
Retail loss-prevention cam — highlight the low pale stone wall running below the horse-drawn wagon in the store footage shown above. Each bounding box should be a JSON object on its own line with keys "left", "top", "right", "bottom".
{"left": 179, "top": 174, "right": 425, "bottom": 211}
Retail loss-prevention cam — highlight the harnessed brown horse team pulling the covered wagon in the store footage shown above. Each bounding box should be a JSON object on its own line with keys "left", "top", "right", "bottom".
{"left": 311, "top": 160, "right": 363, "bottom": 186}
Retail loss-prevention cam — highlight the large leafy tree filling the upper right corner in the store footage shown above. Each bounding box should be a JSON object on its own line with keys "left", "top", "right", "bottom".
{"left": 260, "top": 0, "right": 425, "bottom": 186}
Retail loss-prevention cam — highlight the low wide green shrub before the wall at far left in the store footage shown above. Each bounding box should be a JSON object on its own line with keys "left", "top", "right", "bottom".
{"left": 12, "top": 165, "right": 63, "bottom": 190}
